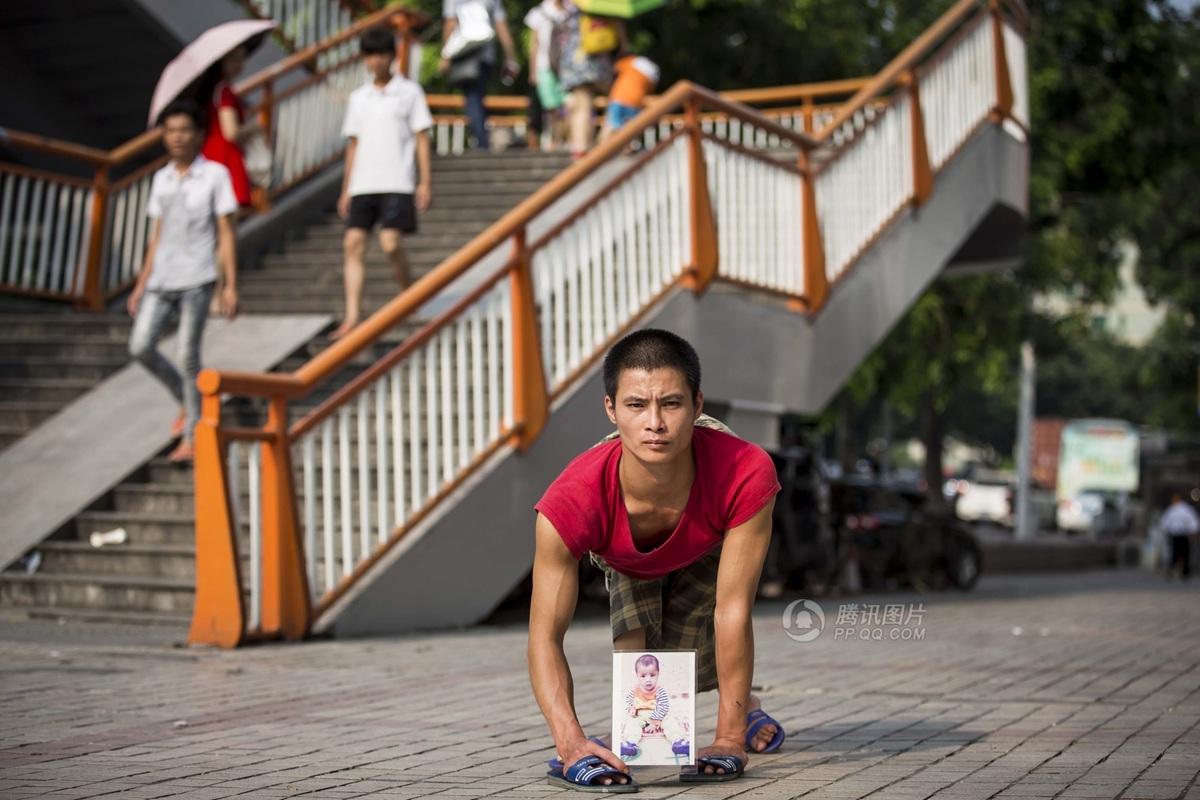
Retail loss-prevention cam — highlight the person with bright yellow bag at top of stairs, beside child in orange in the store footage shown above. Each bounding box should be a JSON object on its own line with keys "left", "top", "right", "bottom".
{"left": 553, "top": 5, "right": 629, "bottom": 158}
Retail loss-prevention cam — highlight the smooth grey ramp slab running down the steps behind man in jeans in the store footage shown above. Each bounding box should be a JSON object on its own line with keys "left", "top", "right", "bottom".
{"left": 0, "top": 314, "right": 331, "bottom": 569}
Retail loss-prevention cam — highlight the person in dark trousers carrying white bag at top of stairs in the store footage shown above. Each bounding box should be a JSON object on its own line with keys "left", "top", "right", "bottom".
{"left": 438, "top": 0, "right": 520, "bottom": 150}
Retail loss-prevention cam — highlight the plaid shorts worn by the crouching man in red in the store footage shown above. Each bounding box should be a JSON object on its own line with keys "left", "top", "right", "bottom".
{"left": 592, "top": 547, "right": 721, "bottom": 692}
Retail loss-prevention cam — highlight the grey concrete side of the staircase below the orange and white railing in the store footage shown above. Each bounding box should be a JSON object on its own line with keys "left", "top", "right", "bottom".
{"left": 318, "top": 126, "right": 1028, "bottom": 636}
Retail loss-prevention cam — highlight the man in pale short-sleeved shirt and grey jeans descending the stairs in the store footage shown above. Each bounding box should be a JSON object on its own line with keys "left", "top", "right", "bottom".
{"left": 126, "top": 101, "right": 238, "bottom": 462}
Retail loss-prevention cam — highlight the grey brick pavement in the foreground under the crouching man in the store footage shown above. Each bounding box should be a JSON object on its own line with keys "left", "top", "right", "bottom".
{"left": 0, "top": 571, "right": 1200, "bottom": 800}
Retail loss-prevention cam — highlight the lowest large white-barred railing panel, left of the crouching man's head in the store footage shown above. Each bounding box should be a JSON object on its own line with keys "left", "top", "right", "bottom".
{"left": 293, "top": 275, "right": 512, "bottom": 599}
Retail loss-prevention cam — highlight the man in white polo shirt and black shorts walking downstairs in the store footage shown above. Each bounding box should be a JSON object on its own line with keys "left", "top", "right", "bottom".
{"left": 334, "top": 29, "right": 433, "bottom": 338}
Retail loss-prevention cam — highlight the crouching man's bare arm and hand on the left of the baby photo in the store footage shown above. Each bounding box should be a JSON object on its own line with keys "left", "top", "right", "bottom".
{"left": 529, "top": 515, "right": 626, "bottom": 770}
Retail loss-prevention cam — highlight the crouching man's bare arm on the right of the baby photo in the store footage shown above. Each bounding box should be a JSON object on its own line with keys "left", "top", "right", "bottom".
{"left": 714, "top": 500, "right": 775, "bottom": 752}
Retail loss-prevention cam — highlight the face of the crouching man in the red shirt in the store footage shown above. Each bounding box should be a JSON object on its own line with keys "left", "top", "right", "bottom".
{"left": 605, "top": 368, "right": 704, "bottom": 464}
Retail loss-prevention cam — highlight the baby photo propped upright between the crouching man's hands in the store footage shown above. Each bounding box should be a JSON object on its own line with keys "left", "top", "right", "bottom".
{"left": 612, "top": 650, "right": 696, "bottom": 766}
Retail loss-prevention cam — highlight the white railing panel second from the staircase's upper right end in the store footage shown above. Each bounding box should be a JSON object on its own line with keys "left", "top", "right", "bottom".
{"left": 816, "top": 91, "right": 913, "bottom": 282}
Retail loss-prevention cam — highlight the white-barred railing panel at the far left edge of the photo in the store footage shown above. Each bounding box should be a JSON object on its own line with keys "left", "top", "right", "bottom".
{"left": 0, "top": 163, "right": 92, "bottom": 294}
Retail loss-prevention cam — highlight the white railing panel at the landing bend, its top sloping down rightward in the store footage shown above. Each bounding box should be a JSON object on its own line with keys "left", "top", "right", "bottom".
{"left": 704, "top": 139, "right": 804, "bottom": 296}
